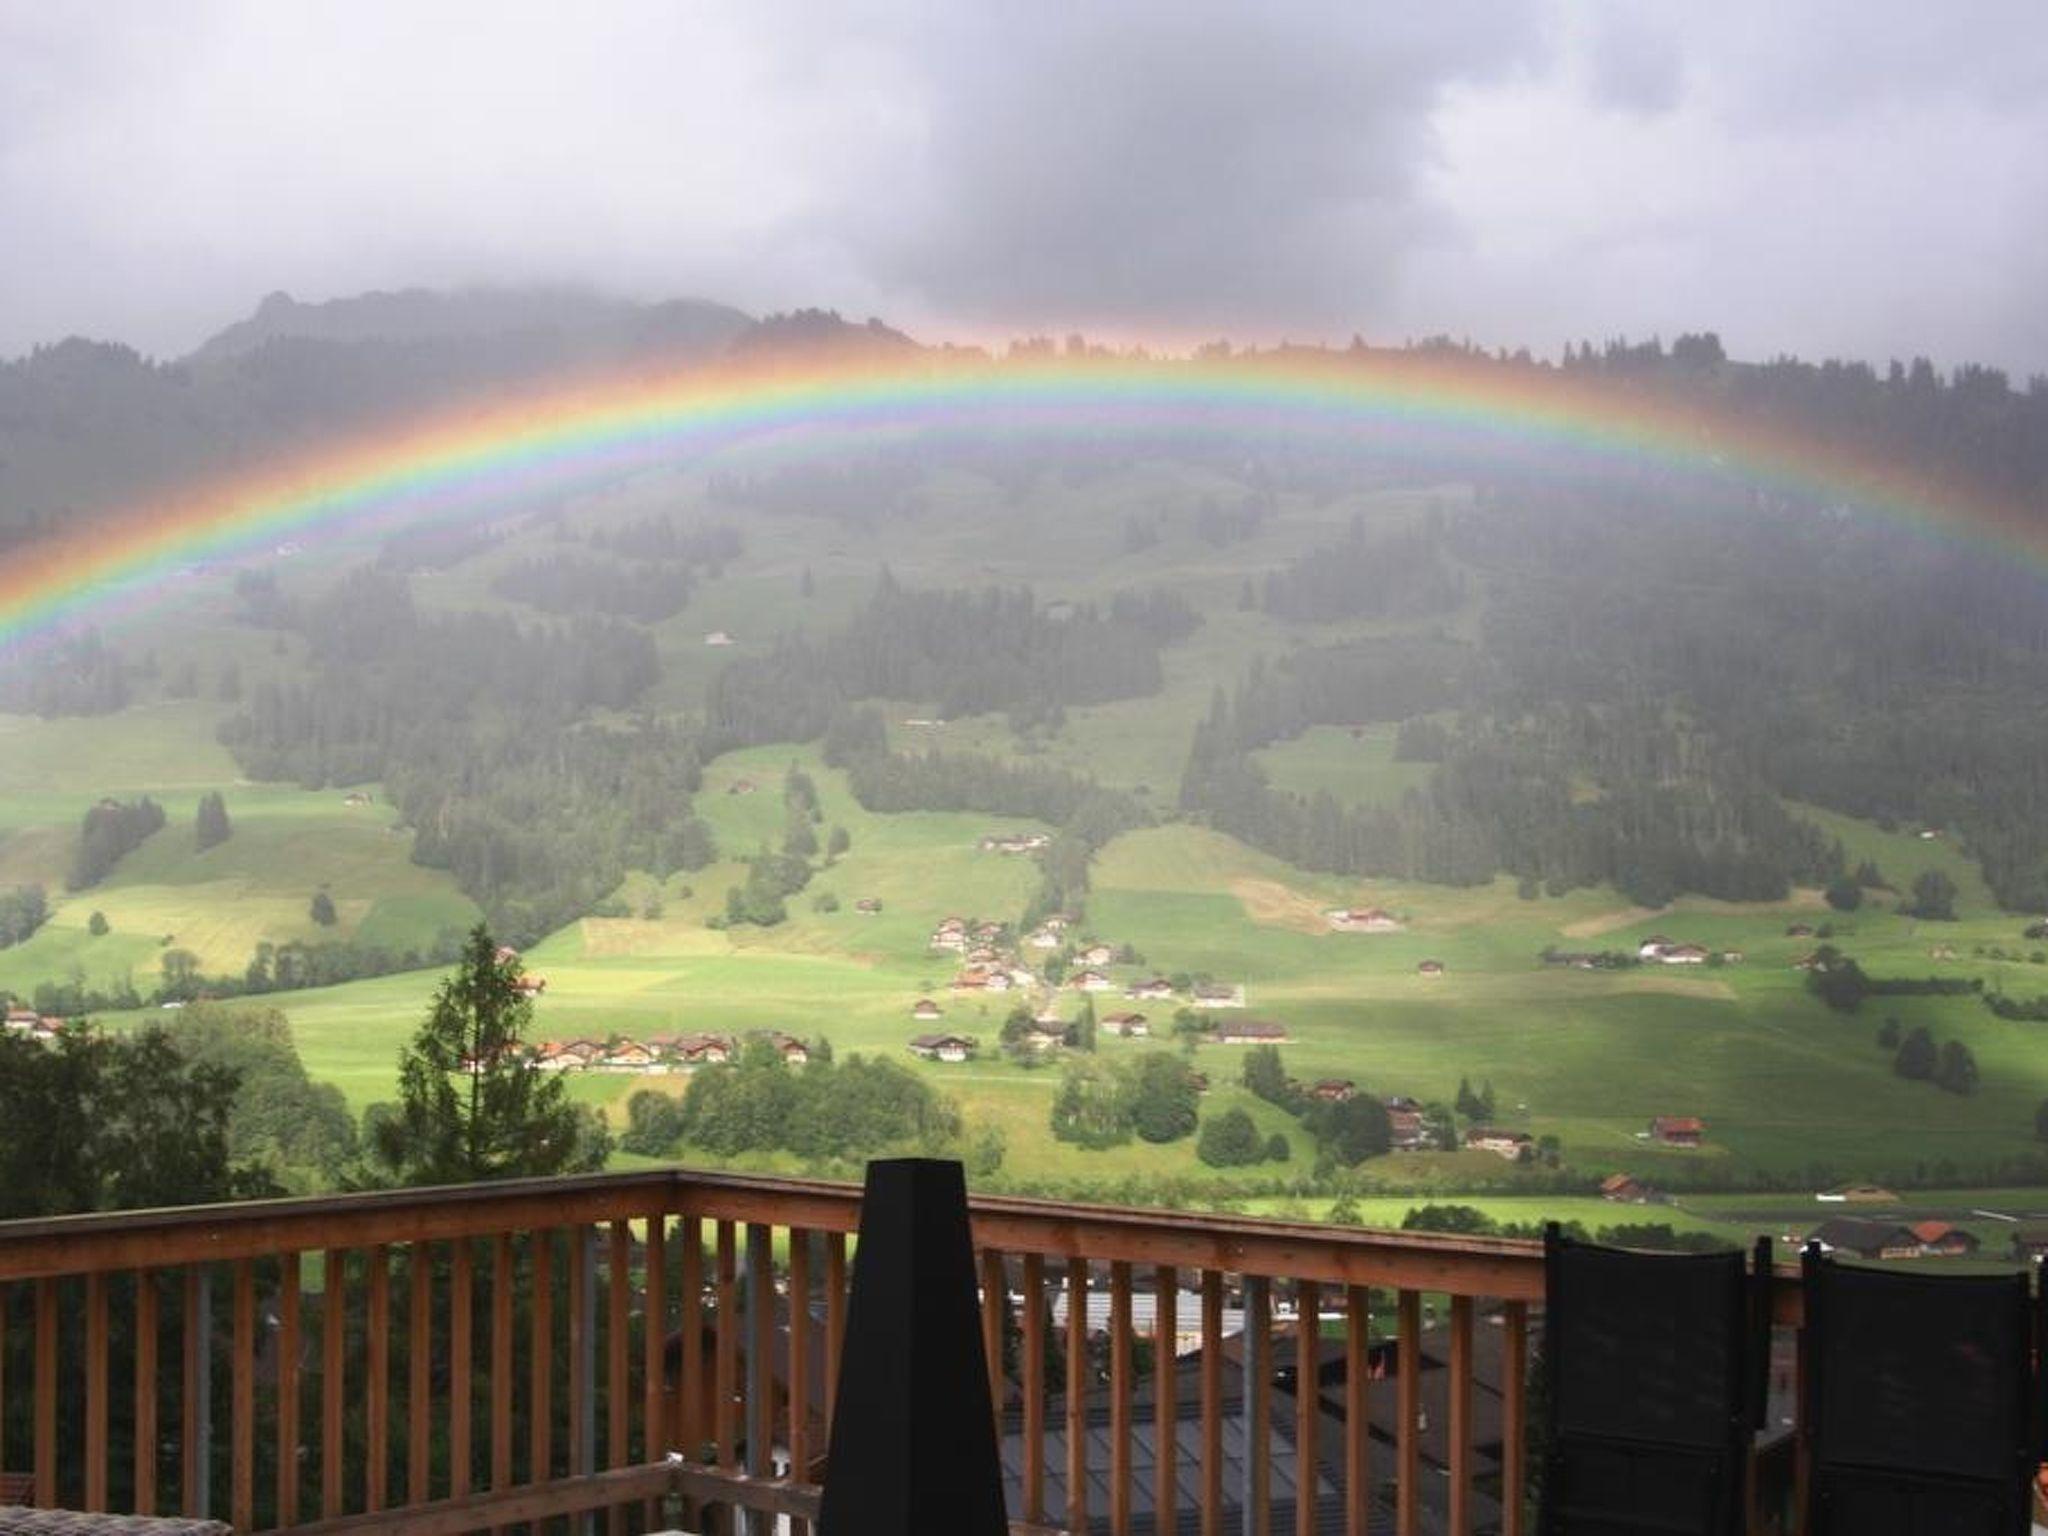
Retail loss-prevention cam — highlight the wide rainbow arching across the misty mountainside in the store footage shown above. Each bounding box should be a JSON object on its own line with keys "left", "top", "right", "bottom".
{"left": 0, "top": 350, "right": 2048, "bottom": 653}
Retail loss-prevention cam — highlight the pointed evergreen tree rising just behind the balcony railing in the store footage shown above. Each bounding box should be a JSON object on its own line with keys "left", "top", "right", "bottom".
{"left": 371, "top": 924, "right": 610, "bottom": 1184}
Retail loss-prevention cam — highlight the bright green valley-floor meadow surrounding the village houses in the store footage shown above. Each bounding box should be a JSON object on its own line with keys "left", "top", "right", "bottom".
{"left": 128, "top": 748, "right": 2048, "bottom": 1221}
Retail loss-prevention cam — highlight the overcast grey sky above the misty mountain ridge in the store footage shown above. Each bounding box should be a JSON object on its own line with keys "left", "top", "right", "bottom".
{"left": 0, "top": 0, "right": 2048, "bottom": 373}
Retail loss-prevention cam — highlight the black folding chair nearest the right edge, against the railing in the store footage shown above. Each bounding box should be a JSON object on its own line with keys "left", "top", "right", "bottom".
{"left": 1800, "top": 1245, "right": 2042, "bottom": 1536}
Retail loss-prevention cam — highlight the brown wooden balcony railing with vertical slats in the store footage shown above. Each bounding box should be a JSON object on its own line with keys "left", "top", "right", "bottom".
{"left": 0, "top": 1169, "right": 1798, "bottom": 1536}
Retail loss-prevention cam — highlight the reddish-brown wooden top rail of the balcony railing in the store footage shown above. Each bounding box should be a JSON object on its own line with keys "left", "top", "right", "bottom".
{"left": 0, "top": 1167, "right": 1790, "bottom": 1300}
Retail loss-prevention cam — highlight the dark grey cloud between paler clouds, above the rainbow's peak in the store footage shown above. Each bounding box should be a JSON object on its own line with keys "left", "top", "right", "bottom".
{"left": 823, "top": 2, "right": 1540, "bottom": 334}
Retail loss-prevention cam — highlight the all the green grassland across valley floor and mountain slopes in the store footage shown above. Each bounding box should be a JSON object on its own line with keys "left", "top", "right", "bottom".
{"left": 16, "top": 465, "right": 2048, "bottom": 1231}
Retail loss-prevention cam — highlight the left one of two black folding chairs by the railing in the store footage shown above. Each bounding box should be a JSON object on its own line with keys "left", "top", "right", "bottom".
{"left": 1542, "top": 1223, "right": 1772, "bottom": 1536}
